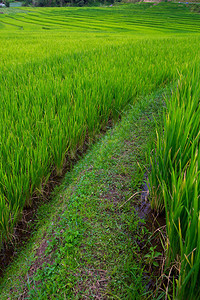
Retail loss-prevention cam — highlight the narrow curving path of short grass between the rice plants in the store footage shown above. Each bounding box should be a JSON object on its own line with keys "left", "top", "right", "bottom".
{"left": 0, "top": 91, "right": 166, "bottom": 299}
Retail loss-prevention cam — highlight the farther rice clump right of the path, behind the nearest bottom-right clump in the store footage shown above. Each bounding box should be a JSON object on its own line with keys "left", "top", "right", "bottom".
{"left": 151, "top": 63, "right": 200, "bottom": 211}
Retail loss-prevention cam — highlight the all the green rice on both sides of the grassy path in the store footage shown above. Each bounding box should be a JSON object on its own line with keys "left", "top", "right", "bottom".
{"left": 0, "top": 3, "right": 200, "bottom": 299}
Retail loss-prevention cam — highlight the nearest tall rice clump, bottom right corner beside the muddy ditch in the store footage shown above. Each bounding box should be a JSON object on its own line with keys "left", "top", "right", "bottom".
{"left": 164, "top": 146, "right": 200, "bottom": 299}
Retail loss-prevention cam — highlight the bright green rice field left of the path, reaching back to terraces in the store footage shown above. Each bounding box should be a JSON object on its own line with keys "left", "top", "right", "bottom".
{"left": 0, "top": 4, "right": 200, "bottom": 298}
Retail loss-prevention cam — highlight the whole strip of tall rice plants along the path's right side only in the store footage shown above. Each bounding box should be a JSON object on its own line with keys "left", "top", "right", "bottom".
{"left": 151, "top": 64, "right": 200, "bottom": 299}
